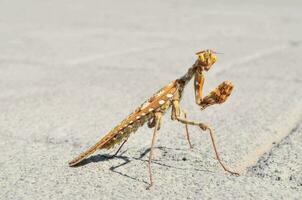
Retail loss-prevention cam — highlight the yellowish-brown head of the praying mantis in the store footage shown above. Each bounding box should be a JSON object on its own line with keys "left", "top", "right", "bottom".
{"left": 196, "top": 49, "right": 217, "bottom": 71}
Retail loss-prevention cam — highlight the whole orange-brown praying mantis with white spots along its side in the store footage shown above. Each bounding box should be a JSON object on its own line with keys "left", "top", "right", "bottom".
{"left": 69, "top": 49, "right": 239, "bottom": 189}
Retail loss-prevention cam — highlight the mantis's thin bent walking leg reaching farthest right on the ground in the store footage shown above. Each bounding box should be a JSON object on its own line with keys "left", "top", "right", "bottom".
{"left": 172, "top": 100, "right": 239, "bottom": 175}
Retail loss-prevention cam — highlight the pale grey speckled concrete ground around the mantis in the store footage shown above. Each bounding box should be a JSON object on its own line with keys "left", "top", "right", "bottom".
{"left": 0, "top": 0, "right": 302, "bottom": 199}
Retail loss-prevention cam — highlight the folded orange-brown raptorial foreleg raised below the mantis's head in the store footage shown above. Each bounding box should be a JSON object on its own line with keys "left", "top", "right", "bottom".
{"left": 194, "top": 72, "right": 234, "bottom": 109}
